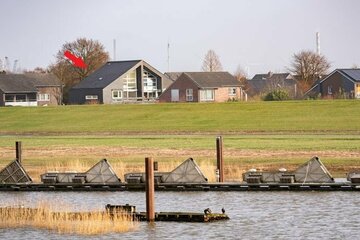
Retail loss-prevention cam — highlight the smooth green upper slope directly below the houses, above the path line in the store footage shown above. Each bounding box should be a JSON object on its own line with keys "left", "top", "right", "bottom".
{"left": 0, "top": 100, "right": 360, "bottom": 134}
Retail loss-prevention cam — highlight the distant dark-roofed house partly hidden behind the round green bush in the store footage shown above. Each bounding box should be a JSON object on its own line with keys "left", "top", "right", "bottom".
{"left": 247, "top": 72, "right": 298, "bottom": 96}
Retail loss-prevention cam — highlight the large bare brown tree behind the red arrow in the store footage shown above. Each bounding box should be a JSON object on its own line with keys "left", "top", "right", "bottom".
{"left": 49, "top": 38, "right": 109, "bottom": 102}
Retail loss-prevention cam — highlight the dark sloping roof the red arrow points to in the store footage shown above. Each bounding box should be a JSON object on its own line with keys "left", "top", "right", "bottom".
{"left": 73, "top": 60, "right": 141, "bottom": 88}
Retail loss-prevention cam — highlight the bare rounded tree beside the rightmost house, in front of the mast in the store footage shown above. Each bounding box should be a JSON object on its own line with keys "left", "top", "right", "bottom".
{"left": 289, "top": 51, "right": 330, "bottom": 88}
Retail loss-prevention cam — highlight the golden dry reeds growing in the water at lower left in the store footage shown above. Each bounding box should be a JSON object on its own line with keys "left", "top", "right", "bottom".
{"left": 0, "top": 204, "right": 138, "bottom": 235}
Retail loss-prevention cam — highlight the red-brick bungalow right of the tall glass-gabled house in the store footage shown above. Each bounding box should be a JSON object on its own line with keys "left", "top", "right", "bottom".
{"left": 159, "top": 72, "right": 243, "bottom": 102}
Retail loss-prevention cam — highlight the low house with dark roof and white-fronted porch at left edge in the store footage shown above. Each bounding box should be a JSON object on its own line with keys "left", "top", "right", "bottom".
{"left": 0, "top": 73, "right": 62, "bottom": 106}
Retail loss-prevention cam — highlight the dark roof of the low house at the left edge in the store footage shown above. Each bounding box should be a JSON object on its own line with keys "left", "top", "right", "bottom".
{"left": 0, "top": 74, "right": 59, "bottom": 93}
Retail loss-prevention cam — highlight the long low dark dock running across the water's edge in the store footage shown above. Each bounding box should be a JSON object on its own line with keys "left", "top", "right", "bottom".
{"left": 0, "top": 182, "right": 360, "bottom": 192}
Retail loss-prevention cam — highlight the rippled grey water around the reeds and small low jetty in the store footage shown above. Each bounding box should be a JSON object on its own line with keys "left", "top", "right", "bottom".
{"left": 0, "top": 192, "right": 360, "bottom": 240}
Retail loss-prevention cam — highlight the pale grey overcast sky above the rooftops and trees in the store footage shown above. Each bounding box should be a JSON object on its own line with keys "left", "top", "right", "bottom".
{"left": 0, "top": 0, "right": 360, "bottom": 76}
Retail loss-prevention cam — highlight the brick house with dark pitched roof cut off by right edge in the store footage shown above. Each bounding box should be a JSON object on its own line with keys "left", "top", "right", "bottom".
{"left": 304, "top": 68, "right": 360, "bottom": 99}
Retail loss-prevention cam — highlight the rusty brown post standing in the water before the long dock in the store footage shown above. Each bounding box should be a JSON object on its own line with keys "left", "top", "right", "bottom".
{"left": 145, "top": 158, "right": 155, "bottom": 222}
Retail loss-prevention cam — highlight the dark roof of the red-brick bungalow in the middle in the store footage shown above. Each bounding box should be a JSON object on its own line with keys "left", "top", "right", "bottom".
{"left": 176, "top": 72, "right": 241, "bottom": 88}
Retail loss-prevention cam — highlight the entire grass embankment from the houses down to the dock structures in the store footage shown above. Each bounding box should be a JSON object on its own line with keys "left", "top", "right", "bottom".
{"left": 0, "top": 100, "right": 360, "bottom": 179}
